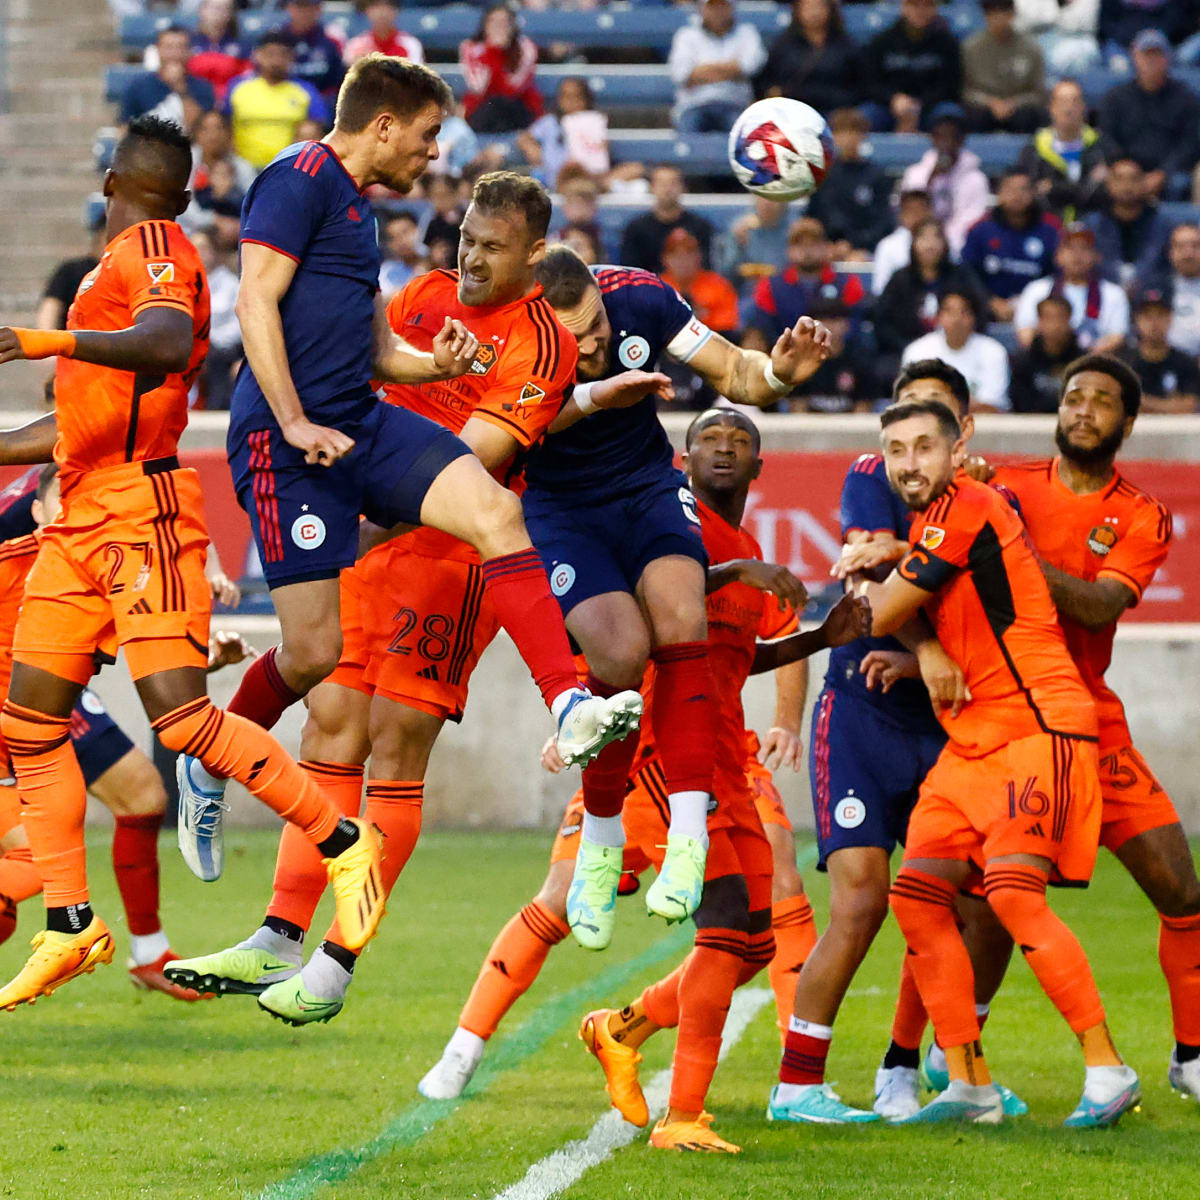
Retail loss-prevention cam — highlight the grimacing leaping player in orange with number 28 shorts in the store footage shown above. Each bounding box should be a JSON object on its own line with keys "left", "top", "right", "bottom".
{"left": 172, "top": 172, "right": 660, "bottom": 1024}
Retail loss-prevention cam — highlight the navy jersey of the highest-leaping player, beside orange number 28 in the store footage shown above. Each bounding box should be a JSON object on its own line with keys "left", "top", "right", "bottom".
{"left": 230, "top": 142, "right": 379, "bottom": 433}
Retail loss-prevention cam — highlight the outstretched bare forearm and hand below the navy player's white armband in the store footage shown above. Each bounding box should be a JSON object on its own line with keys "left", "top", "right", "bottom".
{"left": 688, "top": 317, "right": 830, "bottom": 408}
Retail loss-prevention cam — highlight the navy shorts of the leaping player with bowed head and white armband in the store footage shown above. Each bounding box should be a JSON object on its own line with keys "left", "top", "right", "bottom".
{"left": 522, "top": 469, "right": 708, "bottom": 617}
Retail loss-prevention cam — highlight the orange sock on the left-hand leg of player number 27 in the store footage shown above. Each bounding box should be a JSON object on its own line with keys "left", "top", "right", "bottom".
{"left": 0, "top": 700, "right": 88, "bottom": 908}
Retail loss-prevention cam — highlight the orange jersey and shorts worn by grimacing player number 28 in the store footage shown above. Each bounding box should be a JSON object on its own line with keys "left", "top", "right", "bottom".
{"left": 331, "top": 271, "right": 578, "bottom": 720}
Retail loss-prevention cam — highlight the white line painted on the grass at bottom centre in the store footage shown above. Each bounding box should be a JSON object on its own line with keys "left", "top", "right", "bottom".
{"left": 492, "top": 988, "right": 772, "bottom": 1200}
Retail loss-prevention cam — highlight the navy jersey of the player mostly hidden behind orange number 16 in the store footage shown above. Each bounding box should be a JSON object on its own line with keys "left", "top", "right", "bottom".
{"left": 826, "top": 454, "right": 937, "bottom": 727}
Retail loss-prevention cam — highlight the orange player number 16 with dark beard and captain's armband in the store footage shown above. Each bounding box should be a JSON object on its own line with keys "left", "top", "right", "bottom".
{"left": 853, "top": 401, "right": 1141, "bottom": 1127}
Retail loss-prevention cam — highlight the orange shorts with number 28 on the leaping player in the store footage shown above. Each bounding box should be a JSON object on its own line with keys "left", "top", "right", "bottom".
{"left": 324, "top": 540, "right": 499, "bottom": 721}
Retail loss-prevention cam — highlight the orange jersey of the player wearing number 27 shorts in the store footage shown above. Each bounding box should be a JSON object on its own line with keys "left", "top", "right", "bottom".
{"left": 54, "top": 221, "right": 210, "bottom": 480}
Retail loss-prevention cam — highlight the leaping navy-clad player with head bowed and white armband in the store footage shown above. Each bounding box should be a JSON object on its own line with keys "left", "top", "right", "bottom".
{"left": 523, "top": 247, "right": 829, "bottom": 949}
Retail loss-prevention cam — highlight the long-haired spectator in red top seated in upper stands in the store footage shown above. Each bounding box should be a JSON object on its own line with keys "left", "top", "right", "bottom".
{"left": 458, "top": 4, "right": 546, "bottom": 133}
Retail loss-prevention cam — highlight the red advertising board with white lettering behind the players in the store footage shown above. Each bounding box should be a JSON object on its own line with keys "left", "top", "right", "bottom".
{"left": 0, "top": 449, "right": 1200, "bottom": 622}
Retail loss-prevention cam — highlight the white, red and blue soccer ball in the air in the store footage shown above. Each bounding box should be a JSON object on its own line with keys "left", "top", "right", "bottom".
{"left": 730, "top": 96, "right": 834, "bottom": 200}
